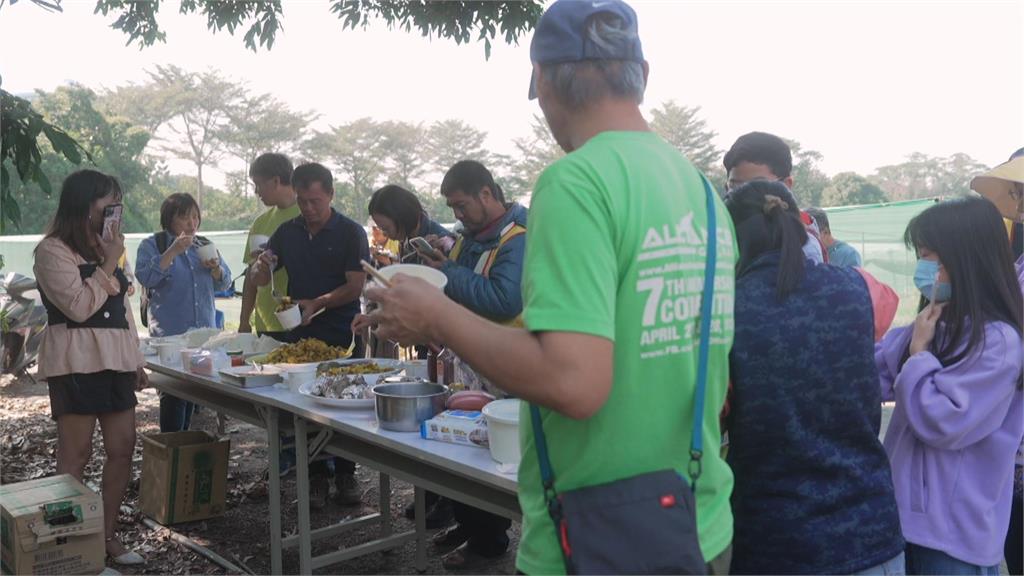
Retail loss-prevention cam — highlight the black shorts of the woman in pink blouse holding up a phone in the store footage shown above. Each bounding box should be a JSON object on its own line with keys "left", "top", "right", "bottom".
{"left": 46, "top": 370, "right": 138, "bottom": 420}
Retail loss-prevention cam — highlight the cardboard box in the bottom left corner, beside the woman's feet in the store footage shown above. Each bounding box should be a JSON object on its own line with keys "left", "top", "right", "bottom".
{"left": 0, "top": 474, "right": 106, "bottom": 574}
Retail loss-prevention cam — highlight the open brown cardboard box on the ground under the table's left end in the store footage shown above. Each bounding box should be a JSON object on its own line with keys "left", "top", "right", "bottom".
{"left": 140, "top": 431, "right": 230, "bottom": 524}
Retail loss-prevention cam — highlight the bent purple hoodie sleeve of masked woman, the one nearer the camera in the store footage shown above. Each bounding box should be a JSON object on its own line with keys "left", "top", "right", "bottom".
{"left": 895, "top": 323, "right": 1022, "bottom": 450}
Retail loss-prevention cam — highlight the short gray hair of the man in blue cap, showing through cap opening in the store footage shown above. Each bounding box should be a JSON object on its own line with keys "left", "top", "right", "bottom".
{"left": 541, "top": 13, "right": 646, "bottom": 108}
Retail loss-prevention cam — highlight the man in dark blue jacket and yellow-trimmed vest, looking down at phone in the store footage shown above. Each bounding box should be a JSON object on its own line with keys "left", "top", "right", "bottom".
{"left": 423, "top": 160, "right": 526, "bottom": 570}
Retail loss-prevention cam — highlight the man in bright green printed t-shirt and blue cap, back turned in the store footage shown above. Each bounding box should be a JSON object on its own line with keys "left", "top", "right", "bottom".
{"left": 366, "top": 0, "right": 736, "bottom": 574}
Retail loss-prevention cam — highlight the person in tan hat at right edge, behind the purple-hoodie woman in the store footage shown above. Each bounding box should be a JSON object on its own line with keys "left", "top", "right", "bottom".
{"left": 971, "top": 148, "right": 1024, "bottom": 574}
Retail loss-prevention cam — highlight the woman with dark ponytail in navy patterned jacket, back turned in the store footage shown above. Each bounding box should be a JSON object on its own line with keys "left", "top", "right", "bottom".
{"left": 726, "top": 181, "right": 904, "bottom": 574}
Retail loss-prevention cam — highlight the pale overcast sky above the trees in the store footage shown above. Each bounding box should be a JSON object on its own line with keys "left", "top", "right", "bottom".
{"left": 0, "top": 0, "right": 1024, "bottom": 186}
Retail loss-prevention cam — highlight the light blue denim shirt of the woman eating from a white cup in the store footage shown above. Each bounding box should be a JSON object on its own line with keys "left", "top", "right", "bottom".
{"left": 135, "top": 233, "right": 231, "bottom": 336}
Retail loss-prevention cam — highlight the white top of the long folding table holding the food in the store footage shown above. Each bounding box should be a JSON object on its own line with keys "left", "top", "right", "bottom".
{"left": 146, "top": 357, "right": 517, "bottom": 494}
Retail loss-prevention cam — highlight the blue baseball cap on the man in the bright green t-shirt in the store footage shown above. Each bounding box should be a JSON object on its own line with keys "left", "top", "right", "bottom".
{"left": 529, "top": 0, "right": 643, "bottom": 99}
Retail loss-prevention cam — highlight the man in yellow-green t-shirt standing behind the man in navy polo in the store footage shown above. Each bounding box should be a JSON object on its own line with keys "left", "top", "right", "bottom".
{"left": 239, "top": 153, "right": 299, "bottom": 339}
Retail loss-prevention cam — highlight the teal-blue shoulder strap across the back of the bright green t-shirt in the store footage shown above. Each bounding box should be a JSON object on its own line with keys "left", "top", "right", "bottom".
{"left": 529, "top": 174, "right": 718, "bottom": 498}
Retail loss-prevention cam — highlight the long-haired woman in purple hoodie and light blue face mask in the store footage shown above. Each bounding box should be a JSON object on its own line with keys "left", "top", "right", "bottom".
{"left": 874, "top": 198, "right": 1024, "bottom": 574}
